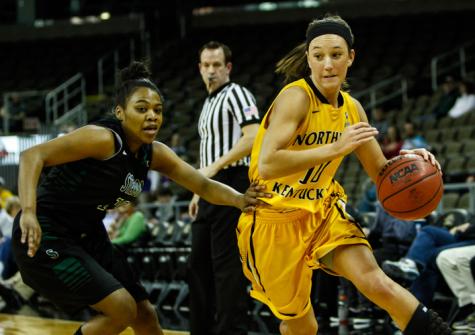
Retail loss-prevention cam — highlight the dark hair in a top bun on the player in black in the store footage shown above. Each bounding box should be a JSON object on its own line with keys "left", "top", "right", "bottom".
{"left": 115, "top": 61, "right": 163, "bottom": 108}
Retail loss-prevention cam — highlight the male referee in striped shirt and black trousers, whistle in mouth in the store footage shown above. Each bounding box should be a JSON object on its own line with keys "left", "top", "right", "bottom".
{"left": 189, "top": 41, "right": 259, "bottom": 335}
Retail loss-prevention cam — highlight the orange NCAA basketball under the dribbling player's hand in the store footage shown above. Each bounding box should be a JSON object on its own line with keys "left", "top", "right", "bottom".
{"left": 377, "top": 154, "right": 444, "bottom": 220}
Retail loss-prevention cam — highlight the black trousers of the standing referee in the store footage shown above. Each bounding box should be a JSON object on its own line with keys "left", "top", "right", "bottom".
{"left": 189, "top": 167, "right": 249, "bottom": 335}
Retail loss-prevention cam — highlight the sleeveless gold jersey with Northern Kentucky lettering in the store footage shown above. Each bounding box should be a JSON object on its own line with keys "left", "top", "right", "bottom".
{"left": 249, "top": 78, "right": 360, "bottom": 213}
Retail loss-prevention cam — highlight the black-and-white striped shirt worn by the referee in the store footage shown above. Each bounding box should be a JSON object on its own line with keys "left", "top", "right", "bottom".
{"left": 198, "top": 82, "right": 260, "bottom": 168}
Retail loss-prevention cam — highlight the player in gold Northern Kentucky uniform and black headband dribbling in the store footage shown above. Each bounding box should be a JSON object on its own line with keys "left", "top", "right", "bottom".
{"left": 237, "top": 16, "right": 450, "bottom": 335}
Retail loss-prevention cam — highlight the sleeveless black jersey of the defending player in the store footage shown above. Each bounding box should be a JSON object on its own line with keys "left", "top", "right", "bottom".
{"left": 37, "top": 118, "right": 152, "bottom": 234}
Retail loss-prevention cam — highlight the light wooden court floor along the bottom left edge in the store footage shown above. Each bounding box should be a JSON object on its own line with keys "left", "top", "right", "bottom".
{"left": 0, "top": 313, "right": 189, "bottom": 335}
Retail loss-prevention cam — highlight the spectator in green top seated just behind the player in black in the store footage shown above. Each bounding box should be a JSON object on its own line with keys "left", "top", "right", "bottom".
{"left": 109, "top": 202, "right": 147, "bottom": 245}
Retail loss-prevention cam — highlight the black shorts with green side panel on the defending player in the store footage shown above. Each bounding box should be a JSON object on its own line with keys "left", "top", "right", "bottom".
{"left": 12, "top": 208, "right": 148, "bottom": 315}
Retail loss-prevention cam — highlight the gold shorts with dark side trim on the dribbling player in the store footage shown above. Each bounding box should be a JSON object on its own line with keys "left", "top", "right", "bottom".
{"left": 237, "top": 199, "right": 371, "bottom": 320}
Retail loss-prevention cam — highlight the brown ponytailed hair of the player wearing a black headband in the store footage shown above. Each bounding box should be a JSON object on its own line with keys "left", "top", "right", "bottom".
{"left": 275, "top": 14, "right": 354, "bottom": 84}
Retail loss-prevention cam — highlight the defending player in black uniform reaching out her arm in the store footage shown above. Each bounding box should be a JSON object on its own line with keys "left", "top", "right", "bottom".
{"left": 12, "top": 62, "right": 272, "bottom": 335}
